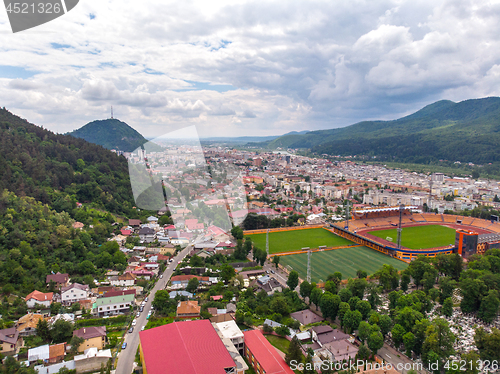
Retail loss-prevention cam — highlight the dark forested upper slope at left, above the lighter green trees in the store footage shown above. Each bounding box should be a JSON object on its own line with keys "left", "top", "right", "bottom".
{"left": 0, "top": 109, "right": 134, "bottom": 214}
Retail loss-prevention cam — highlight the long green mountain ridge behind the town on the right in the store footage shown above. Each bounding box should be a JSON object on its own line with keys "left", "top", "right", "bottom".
{"left": 252, "top": 97, "right": 500, "bottom": 164}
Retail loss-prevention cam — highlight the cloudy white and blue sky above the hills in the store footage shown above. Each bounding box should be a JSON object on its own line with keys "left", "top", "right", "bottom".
{"left": 0, "top": 0, "right": 500, "bottom": 137}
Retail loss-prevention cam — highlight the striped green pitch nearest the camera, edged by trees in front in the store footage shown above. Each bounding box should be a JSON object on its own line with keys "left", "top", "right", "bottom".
{"left": 280, "top": 247, "right": 408, "bottom": 282}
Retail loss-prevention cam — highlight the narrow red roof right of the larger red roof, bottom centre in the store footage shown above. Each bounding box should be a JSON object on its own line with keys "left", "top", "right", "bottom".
{"left": 244, "top": 330, "right": 294, "bottom": 374}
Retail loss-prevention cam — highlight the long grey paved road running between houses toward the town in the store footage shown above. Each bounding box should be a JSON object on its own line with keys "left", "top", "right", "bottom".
{"left": 115, "top": 245, "right": 192, "bottom": 374}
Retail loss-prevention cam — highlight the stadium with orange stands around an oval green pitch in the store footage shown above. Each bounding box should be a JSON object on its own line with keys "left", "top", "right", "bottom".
{"left": 331, "top": 206, "right": 500, "bottom": 262}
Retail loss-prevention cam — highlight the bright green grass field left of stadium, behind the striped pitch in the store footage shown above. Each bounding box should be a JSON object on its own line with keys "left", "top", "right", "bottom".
{"left": 245, "top": 228, "right": 353, "bottom": 253}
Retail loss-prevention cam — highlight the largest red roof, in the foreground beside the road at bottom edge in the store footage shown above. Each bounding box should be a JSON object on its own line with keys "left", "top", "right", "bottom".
{"left": 139, "top": 319, "right": 235, "bottom": 374}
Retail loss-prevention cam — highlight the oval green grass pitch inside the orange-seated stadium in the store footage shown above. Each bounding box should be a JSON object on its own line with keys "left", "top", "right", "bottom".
{"left": 369, "top": 225, "right": 455, "bottom": 249}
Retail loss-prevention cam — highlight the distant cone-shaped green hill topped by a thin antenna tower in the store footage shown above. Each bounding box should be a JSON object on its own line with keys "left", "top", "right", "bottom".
{"left": 69, "top": 118, "right": 154, "bottom": 152}
